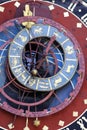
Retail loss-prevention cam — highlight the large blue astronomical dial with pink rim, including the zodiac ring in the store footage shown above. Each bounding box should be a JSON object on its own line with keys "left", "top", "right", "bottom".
{"left": 1, "top": 16, "right": 85, "bottom": 117}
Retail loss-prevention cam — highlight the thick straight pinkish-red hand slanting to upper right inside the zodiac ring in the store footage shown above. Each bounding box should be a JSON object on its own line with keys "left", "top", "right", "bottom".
{"left": 37, "top": 36, "right": 56, "bottom": 69}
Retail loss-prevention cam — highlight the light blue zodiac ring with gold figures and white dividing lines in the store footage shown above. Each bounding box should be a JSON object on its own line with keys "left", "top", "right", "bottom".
{"left": 9, "top": 22, "right": 78, "bottom": 91}
